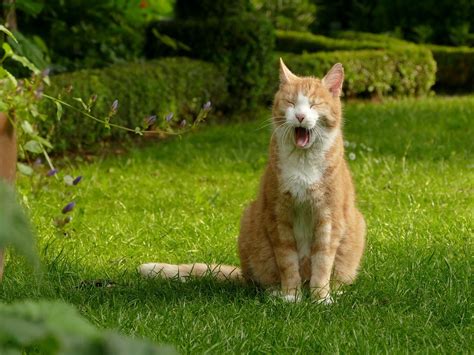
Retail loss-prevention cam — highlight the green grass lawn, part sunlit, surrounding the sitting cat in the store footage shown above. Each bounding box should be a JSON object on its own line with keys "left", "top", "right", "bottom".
{"left": 0, "top": 96, "right": 474, "bottom": 354}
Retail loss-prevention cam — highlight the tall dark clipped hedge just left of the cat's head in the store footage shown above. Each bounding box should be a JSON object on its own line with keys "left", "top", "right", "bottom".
{"left": 146, "top": 13, "right": 274, "bottom": 110}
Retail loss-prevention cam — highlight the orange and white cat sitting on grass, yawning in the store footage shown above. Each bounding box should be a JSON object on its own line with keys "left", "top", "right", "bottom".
{"left": 140, "top": 60, "right": 366, "bottom": 303}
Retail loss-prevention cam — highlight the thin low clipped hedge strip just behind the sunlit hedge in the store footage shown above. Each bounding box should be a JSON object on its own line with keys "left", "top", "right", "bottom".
{"left": 276, "top": 31, "right": 415, "bottom": 53}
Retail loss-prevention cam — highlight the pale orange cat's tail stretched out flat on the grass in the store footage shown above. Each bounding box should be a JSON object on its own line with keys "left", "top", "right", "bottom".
{"left": 138, "top": 263, "right": 241, "bottom": 282}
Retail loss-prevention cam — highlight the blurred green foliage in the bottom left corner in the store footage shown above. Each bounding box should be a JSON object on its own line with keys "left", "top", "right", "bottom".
{"left": 0, "top": 301, "right": 176, "bottom": 355}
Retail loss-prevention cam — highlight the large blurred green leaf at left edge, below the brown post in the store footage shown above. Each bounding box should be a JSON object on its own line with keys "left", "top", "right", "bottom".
{"left": 0, "top": 182, "right": 39, "bottom": 268}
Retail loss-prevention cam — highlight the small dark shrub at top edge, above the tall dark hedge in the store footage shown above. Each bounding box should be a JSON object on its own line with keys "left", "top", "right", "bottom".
{"left": 174, "top": 0, "right": 253, "bottom": 21}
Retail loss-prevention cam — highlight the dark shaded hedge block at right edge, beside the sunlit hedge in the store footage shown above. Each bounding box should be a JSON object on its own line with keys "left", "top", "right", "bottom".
{"left": 428, "top": 46, "right": 474, "bottom": 92}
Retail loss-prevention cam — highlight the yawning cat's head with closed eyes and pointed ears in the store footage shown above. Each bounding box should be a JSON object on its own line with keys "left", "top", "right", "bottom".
{"left": 273, "top": 59, "right": 344, "bottom": 149}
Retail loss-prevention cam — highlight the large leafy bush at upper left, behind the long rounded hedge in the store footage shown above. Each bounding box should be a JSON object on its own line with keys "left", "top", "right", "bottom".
{"left": 17, "top": 0, "right": 172, "bottom": 72}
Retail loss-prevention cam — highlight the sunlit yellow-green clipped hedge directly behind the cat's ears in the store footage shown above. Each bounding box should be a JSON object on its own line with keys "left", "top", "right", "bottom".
{"left": 266, "top": 48, "right": 436, "bottom": 97}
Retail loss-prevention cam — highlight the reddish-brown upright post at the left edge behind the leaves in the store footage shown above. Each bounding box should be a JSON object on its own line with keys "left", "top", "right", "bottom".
{"left": 0, "top": 112, "right": 17, "bottom": 281}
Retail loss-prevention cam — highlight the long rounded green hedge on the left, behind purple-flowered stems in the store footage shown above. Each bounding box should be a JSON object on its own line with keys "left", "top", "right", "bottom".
{"left": 41, "top": 58, "right": 227, "bottom": 152}
